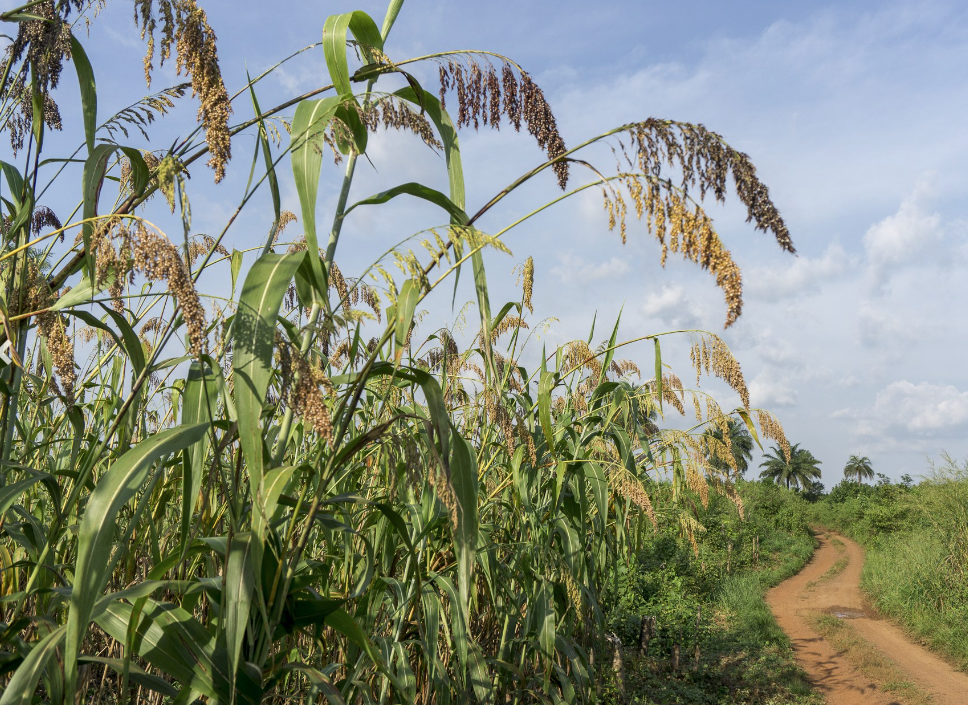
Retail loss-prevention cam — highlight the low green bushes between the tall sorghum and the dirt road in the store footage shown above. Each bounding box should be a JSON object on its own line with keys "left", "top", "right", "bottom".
{"left": 603, "top": 482, "right": 819, "bottom": 705}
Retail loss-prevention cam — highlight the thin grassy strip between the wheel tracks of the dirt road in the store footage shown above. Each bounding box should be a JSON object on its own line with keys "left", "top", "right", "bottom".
{"left": 805, "top": 612, "right": 934, "bottom": 705}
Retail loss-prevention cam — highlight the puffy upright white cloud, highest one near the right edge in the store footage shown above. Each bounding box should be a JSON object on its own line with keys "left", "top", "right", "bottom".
{"left": 864, "top": 182, "right": 944, "bottom": 284}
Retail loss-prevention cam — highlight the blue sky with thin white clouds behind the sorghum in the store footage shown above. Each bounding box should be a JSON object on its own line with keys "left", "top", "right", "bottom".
{"left": 0, "top": 0, "right": 968, "bottom": 488}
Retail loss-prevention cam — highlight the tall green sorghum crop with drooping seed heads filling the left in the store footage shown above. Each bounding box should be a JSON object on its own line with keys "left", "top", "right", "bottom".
{"left": 0, "top": 0, "right": 803, "bottom": 705}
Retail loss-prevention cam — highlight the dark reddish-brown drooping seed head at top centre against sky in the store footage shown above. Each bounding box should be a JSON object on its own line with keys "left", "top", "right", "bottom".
{"left": 440, "top": 59, "right": 568, "bottom": 190}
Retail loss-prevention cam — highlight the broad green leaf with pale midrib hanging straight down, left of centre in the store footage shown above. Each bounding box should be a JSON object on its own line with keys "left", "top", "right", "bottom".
{"left": 232, "top": 252, "right": 305, "bottom": 490}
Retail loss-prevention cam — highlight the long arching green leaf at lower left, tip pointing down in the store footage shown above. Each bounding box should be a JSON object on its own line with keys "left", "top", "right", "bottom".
{"left": 64, "top": 424, "right": 208, "bottom": 693}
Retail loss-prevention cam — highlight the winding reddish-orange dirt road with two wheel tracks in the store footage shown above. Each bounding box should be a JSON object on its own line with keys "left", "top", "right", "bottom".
{"left": 767, "top": 533, "right": 968, "bottom": 705}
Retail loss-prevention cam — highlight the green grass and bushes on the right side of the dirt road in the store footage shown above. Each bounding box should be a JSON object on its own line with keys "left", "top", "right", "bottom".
{"left": 814, "top": 456, "right": 968, "bottom": 669}
